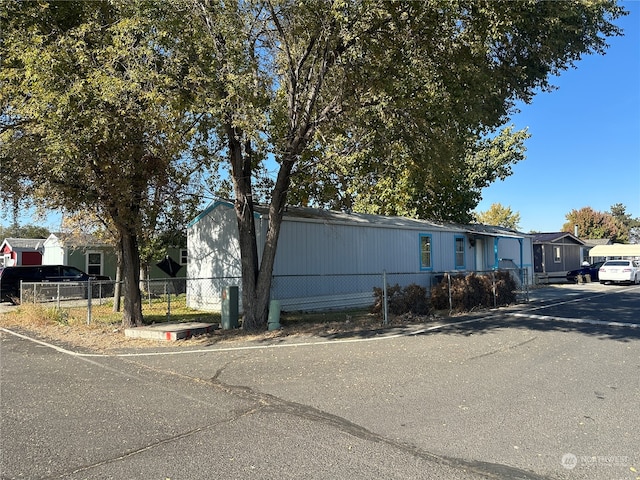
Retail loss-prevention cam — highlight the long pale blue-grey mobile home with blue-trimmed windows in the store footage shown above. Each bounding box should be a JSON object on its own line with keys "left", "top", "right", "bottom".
{"left": 187, "top": 201, "right": 532, "bottom": 311}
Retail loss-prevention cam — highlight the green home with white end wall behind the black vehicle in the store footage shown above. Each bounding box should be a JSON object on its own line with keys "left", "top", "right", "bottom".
{"left": 42, "top": 233, "right": 116, "bottom": 279}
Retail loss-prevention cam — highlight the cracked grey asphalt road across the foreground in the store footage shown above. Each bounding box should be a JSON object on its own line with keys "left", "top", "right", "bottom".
{"left": 0, "top": 284, "right": 640, "bottom": 480}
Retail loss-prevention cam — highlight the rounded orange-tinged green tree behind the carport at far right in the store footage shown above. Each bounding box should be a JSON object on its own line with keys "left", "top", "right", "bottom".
{"left": 562, "top": 203, "right": 640, "bottom": 243}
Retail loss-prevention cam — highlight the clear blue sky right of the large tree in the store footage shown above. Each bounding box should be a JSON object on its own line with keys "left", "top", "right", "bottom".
{"left": 477, "top": 0, "right": 640, "bottom": 232}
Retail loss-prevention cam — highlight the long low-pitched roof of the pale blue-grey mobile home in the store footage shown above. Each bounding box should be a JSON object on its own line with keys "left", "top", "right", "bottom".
{"left": 189, "top": 200, "right": 528, "bottom": 238}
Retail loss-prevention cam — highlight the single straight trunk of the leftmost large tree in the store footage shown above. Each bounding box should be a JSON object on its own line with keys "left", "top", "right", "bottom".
{"left": 120, "top": 231, "right": 142, "bottom": 328}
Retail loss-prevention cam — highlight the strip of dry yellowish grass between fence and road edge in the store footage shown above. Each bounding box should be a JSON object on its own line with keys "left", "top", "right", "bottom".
{"left": 0, "top": 305, "right": 436, "bottom": 352}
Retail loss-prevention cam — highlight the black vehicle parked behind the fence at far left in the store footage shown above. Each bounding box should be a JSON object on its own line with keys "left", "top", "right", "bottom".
{"left": 0, "top": 265, "right": 111, "bottom": 303}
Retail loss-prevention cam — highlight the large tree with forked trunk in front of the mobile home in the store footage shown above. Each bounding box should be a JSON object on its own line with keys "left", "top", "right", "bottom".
{"left": 193, "top": 0, "right": 623, "bottom": 328}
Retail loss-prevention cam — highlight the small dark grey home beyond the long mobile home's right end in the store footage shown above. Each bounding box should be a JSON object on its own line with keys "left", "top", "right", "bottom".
{"left": 532, "top": 232, "right": 585, "bottom": 278}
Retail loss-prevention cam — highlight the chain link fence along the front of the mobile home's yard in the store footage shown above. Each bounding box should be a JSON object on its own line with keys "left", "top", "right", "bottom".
{"left": 20, "top": 269, "right": 530, "bottom": 322}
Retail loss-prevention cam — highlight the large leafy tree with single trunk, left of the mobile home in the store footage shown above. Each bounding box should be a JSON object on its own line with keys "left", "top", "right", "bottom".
{"left": 0, "top": 0, "right": 210, "bottom": 326}
